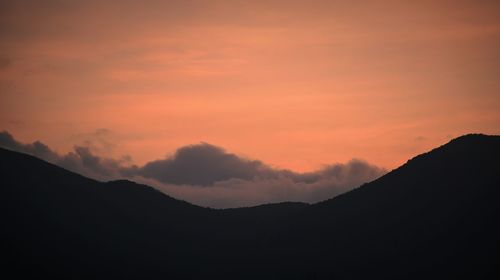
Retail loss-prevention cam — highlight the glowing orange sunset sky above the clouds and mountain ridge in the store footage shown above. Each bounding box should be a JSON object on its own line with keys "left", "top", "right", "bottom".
{"left": 0, "top": 0, "right": 500, "bottom": 171}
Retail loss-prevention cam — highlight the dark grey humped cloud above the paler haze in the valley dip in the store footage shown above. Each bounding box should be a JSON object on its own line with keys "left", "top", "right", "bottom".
{"left": 122, "top": 143, "right": 383, "bottom": 189}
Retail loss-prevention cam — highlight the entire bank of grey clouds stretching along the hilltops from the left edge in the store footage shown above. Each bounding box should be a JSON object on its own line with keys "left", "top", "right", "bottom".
{"left": 0, "top": 131, "right": 386, "bottom": 208}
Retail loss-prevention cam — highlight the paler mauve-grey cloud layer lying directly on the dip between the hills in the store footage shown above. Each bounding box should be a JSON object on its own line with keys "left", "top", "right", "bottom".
{"left": 139, "top": 160, "right": 386, "bottom": 208}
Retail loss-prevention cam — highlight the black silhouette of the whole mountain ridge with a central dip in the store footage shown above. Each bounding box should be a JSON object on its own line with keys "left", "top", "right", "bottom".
{"left": 0, "top": 135, "right": 500, "bottom": 279}
